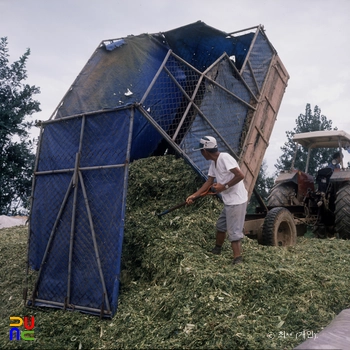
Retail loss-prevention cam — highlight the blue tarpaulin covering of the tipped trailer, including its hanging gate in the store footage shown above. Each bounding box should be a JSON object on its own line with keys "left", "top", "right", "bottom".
{"left": 27, "top": 22, "right": 284, "bottom": 317}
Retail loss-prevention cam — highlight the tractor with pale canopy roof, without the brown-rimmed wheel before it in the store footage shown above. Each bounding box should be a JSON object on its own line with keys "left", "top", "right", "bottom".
{"left": 267, "top": 130, "right": 350, "bottom": 239}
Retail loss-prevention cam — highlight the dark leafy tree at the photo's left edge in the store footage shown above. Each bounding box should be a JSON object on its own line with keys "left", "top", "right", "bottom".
{"left": 0, "top": 37, "right": 40, "bottom": 215}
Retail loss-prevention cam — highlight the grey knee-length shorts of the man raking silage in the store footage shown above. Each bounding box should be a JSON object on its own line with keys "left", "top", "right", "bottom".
{"left": 216, "top": 202, "right": 247, "bottom": 242}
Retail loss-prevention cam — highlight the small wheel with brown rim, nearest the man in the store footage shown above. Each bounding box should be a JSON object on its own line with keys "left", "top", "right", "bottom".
{"left": 262, "top": 207, "right": 297, "bottom": 246}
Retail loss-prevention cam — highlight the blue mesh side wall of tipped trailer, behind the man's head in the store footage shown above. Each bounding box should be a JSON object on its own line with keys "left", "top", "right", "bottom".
{"left": 138, "top": 37, "right": 264, "bottom": 175}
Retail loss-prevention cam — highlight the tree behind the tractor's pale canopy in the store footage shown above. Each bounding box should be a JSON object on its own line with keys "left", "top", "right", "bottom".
{"left": 275, "top": 104, "right": 337, "bottom": 176}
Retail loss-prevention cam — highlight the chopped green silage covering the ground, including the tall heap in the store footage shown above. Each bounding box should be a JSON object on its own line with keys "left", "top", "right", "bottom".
{"left": 0, "top": 156, "right": 350, "bottom": 349}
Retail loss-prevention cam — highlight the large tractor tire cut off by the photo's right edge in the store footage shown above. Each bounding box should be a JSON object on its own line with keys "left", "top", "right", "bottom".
{"left": 335, "top": 182, "right": 350, "bottom": 239}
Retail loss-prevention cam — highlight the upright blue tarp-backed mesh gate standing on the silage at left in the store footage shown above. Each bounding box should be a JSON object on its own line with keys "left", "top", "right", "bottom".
{"left": 28, "top": 109, "right": 132, "bottom": 316}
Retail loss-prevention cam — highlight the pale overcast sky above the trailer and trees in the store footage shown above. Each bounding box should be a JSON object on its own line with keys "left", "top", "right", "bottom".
{"left": 0, "top": 0, "right": 350, "bottom": 175}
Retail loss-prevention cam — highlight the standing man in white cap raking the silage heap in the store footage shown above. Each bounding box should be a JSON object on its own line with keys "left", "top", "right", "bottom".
{"left": 186, "top": 136, "right": 248, "bottom": 265}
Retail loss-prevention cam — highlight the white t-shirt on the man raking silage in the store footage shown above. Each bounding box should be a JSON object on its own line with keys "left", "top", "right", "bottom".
{"left": 208, "top": 152, "right": 248, "bottom": 205}
